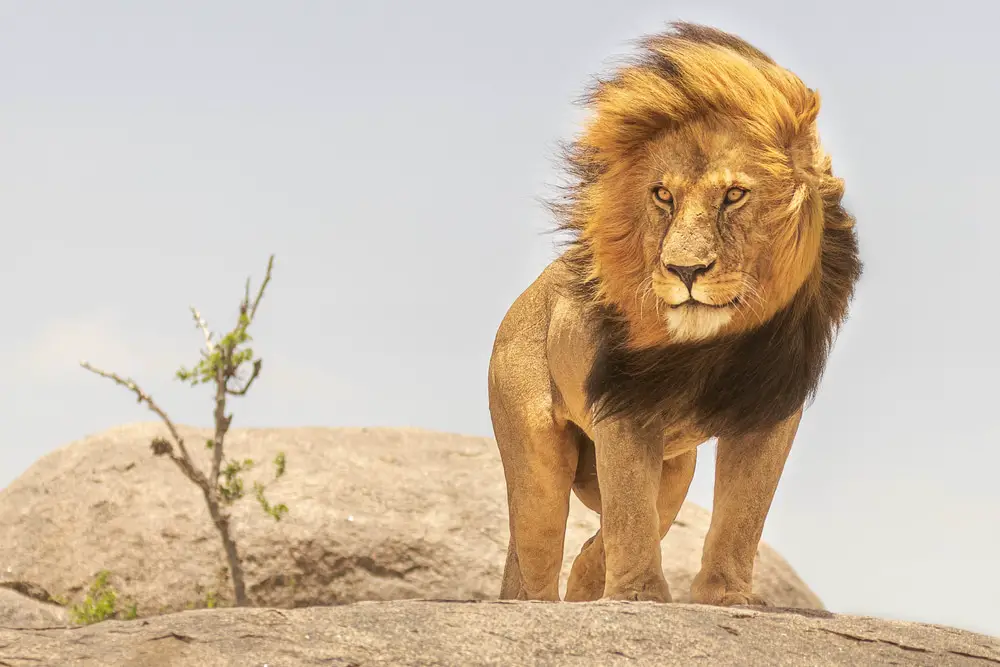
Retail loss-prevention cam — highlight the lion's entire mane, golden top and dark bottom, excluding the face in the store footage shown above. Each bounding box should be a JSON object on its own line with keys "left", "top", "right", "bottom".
{"left": 551, "top": 23, "right": 861, "bottom": 433}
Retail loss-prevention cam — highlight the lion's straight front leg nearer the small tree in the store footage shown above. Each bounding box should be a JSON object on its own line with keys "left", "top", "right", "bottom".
{"left": 594, "top": 421, "right": 670, "bottom": 602}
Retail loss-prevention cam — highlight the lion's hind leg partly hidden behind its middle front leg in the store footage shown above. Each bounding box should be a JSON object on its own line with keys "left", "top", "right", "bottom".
{"left": 566, "top": 446, "right": 697, "bottom": 602}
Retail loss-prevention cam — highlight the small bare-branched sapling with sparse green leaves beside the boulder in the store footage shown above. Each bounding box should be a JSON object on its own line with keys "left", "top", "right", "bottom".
{"left": 80, "top": 255, "right": 288, "bottom": 608}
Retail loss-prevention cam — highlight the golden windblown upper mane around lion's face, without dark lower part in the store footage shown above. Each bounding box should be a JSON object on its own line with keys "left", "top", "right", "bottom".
{"left": 551, "top": 23, "right": 851, "bottom": 333}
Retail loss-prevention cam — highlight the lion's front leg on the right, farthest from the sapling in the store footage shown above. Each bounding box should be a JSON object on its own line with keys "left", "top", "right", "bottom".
{"left": 691, "top": 409, "right": 802, "bottom": 606}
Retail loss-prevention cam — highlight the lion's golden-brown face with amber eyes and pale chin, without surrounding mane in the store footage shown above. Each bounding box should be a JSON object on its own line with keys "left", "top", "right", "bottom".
{"left": 621, "top": 121, "right": 819, "bottom": 342}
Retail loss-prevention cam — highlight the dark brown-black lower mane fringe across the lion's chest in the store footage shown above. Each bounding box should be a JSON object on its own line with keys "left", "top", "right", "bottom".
{"left": 586, "top": 220, "right": 862, "bottom": 436}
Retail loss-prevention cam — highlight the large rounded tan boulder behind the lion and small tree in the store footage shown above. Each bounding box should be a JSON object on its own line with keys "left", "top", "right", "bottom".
{"left": 0, "top": 424, "right": 822, "bottom": 616}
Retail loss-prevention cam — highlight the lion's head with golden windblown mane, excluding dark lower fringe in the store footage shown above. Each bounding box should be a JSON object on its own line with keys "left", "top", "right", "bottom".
{"left": 556, "top": 26, "right": 844, "bottom": 349}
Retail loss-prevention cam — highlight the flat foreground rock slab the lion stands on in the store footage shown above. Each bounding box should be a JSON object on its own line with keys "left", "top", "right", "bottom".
{"left": 0, "top": 601, "right": 1000, "bottom": 667}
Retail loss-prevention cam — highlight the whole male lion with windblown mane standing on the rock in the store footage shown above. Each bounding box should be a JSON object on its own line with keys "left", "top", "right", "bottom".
{"left": 489, "top": 23, "right": 861, "bottom": 605}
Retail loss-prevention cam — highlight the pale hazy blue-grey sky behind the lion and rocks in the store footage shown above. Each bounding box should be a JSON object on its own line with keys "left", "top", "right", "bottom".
{"left": 0, "top": 0, "right": 1000, "bottom": 634}
